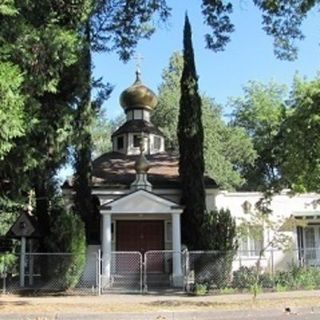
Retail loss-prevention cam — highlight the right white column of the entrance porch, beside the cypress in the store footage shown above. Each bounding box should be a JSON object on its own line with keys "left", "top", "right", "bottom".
{"left": 171, "top": 213, "right": 182, "bottom": 286}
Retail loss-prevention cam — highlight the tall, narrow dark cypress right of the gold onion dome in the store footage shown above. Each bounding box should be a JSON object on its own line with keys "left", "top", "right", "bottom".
{"left": 178, "top": 15, "right": 206, "bottom": 249}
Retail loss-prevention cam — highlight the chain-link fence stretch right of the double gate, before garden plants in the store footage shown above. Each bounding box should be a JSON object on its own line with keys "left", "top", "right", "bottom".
{"left": 185, "top": 248, "right": 320, "bottom": 292}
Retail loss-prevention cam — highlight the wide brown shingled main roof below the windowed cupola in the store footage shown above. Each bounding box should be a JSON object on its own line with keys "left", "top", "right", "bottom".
{"left": 71, "top": 152, "right": 218, "bottom": 189}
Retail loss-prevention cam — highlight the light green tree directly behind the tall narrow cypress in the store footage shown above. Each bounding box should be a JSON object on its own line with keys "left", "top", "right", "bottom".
{"left": 152, "top": 52, "right": 255, "bottom": 189}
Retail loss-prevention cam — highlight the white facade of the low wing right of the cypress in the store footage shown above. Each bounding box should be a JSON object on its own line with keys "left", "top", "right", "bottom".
{"left": 215, "top": 191, "right": 320, "bottom": 271}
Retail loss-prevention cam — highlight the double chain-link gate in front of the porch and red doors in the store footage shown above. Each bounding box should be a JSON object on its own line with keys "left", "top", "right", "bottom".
{"left": 98, "top": 250, "right": 186, "bottom": 293}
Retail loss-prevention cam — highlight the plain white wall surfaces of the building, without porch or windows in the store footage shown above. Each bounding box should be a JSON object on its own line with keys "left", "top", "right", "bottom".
{"left": 93, "top": 189, "right": 320, "bottom": 270}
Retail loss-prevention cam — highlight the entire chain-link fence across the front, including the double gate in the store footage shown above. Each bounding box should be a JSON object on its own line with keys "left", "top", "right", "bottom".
{"left": 0, "top": 248, "right": 320, "bottom": 295}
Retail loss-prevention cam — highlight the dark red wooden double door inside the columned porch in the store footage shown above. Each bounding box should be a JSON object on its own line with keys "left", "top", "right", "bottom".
{"left": 116, "top": 220, "right": 164, "bottom": 272}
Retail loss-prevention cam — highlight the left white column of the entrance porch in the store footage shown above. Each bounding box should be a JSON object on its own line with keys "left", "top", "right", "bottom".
{"left": 102, "top": 212, "right": 112, "bottom": 285}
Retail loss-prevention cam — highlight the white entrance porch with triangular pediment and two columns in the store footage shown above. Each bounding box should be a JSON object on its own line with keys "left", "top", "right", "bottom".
{"left": 100, "top": 190, "right": 183, "bottom": 286}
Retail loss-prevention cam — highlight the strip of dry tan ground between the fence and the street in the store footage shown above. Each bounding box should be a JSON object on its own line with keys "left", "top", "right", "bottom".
{"left": 0, "top": 291, "right": 320, "bottom": 315}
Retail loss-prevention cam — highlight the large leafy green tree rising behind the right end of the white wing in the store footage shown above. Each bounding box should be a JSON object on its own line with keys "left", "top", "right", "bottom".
{"left": 231, "top": 76, "right": 320, "bottom": 192}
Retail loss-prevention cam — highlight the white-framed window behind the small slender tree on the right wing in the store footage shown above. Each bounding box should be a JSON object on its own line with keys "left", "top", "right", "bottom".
{"left": 239, "top": 226, "right": 263, "bottom": 257}
